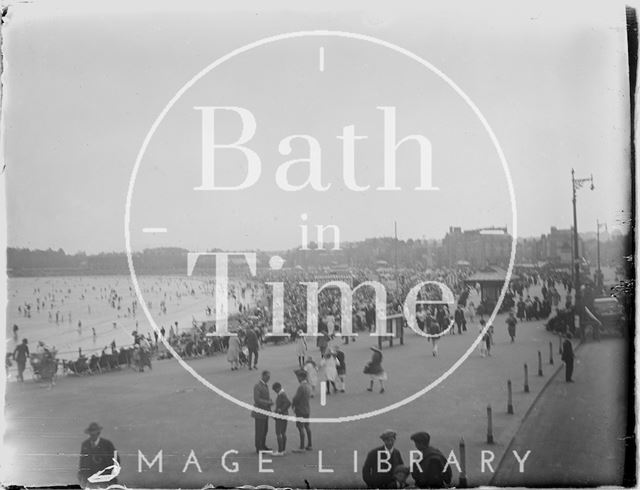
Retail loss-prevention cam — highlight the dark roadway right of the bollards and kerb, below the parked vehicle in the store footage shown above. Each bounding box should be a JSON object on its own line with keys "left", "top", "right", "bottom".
{"left": 492, "top": 338, "right": 635, "bottom": 487}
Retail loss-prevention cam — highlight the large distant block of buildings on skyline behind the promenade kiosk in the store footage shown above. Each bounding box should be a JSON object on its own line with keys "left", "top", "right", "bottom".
{"left": 442, "top": 226, "right": 512, "bottom": 268}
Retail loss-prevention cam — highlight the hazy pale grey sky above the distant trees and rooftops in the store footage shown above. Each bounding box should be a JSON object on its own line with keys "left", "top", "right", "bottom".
{"left": 3, "top": 2, "right": 630, "bottom": 252}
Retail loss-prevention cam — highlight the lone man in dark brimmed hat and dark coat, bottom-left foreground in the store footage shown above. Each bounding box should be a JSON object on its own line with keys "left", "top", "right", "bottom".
{"left": 78, "top": 422, "right": 120, "bottom": 487}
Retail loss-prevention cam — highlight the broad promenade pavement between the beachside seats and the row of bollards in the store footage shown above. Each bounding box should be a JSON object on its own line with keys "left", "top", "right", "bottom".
{"left": 3, "top": 296, "right": 559, "bottom": 488}
